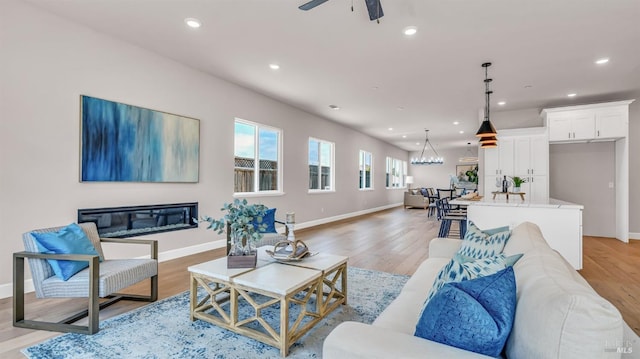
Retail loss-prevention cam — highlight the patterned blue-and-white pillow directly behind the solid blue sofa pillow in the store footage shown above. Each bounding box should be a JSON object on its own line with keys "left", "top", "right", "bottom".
{"left": 425, "top": 253, "right": 522, "bottom": 303}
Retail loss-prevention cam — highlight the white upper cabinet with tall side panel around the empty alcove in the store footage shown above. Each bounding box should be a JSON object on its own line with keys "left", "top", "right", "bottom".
{"left": 541, "top": 100, "right": 635, "bottom": 242}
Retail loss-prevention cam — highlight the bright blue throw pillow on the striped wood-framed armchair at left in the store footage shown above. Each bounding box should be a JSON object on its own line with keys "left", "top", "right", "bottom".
{"left": 31, "top": 223, "right": 99, "bottom": 281}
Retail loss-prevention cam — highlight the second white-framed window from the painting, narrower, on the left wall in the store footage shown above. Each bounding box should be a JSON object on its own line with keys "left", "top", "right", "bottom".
{"left": 309, "top": 137, "right": 335, "bottom": 192}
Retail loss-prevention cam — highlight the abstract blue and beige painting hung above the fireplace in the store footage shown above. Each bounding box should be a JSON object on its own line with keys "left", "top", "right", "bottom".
{"left": 80, "top": 96, "right": 200, "bottom": 182}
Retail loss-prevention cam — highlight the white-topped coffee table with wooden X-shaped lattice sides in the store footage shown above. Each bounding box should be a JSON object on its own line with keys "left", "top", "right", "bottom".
{"left": 188, "top": 246, "right": 348, "bottom": 357}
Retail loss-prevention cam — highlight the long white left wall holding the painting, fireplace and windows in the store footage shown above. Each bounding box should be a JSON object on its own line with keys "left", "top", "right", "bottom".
{"left": 0, "top": 0, "right": 407, "bottom": 287}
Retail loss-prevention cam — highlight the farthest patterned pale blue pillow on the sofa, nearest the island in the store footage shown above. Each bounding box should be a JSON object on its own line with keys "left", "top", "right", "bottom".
{"left": 458, "top": 222, "right": 511, "bottom": 259}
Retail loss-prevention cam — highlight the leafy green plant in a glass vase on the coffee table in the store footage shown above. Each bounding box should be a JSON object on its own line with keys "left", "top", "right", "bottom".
{"left": 201, "top": 198, "right": 270, "bottom": 268}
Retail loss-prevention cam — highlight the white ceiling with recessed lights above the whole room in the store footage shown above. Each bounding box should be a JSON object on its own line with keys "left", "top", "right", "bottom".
{"left": 22, "top": 0, "right": 640, "bottom": 151}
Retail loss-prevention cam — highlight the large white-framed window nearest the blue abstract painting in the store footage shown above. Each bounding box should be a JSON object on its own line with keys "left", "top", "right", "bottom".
{"left": 234, "top": 119, "right": 282, "bottom": 193}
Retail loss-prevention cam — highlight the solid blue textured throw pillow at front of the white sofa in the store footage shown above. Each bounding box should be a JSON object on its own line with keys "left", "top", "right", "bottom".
{"left": 414, "top": 267, "right": 516, "bottom": 357}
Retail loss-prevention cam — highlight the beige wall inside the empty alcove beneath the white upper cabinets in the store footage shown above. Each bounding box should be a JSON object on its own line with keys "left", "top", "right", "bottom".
{"left": 549, "top": 142, "right": 616, "bottom": 237}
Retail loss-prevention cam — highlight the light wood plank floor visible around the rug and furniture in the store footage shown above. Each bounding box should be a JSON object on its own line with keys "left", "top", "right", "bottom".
{"left": 0, "top": 207, "right": 640, "bottom": 358}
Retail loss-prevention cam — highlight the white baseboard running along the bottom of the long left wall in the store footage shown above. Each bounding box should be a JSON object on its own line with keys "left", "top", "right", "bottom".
{"left": 0, "top": 203, "right": 400, "bottom": 299}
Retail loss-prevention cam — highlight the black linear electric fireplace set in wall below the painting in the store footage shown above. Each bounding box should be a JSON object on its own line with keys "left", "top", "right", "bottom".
{"left": 78, "top": 202, "right": 198, "bottom": 238}
